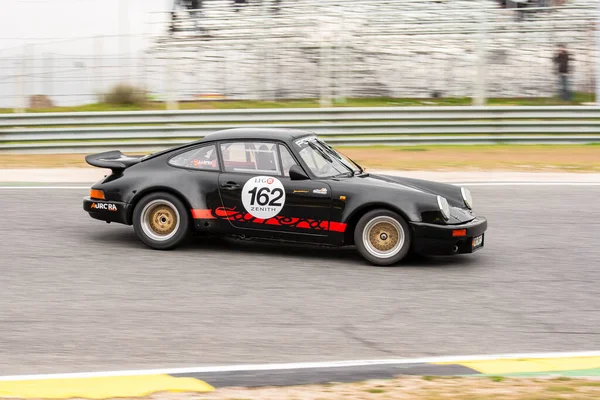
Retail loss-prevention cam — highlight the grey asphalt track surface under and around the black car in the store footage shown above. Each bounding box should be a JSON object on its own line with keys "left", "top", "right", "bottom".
{"left": 0, "top": 186, "right": 600, "bottom": 375}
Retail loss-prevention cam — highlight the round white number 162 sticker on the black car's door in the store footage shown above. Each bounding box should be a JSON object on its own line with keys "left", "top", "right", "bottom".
{"left": 242, "top": 176, "right": 285, "bottom": 219}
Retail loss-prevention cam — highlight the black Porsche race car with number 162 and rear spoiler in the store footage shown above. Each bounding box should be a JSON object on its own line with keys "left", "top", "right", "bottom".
{"left": 83, "top": 128, "right": 487, "bottom": 265}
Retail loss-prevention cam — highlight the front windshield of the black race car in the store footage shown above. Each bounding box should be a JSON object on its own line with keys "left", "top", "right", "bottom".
{"left": 294, "top": 136, "right": 362, "bottom": 178}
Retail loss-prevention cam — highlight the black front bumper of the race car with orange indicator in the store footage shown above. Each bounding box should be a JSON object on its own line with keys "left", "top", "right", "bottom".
{"left": 411, "top": 217, "right": 487, "bottom": 255}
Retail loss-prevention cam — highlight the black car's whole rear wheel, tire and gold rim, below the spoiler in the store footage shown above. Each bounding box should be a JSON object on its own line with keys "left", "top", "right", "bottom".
{"left": 133, "top": 192, "right": 191, "bottom": 250}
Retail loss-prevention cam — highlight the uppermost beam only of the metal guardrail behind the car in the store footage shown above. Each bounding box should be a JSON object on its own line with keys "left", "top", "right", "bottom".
{"left": 0, "top": 106, "right": 600, "bottom": 127}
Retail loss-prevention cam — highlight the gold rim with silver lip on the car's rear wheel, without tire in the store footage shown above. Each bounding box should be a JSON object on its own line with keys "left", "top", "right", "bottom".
{"left": 140, "top": 199, "right": 180, "bottom": 242}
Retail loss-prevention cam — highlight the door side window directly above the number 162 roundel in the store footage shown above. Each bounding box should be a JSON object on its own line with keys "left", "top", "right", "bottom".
{"left": 221, "top": 142, "right": 281, "bottom": 175}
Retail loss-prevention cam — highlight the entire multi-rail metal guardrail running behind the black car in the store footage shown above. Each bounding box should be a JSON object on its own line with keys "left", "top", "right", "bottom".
{"left": 0, "top": 106, "right": 600, "bottom": 151}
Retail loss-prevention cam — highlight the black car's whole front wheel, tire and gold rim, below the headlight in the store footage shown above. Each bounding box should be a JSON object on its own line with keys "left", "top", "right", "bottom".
{"left": 354, "top": 209, "right": 411, "bottom": 266}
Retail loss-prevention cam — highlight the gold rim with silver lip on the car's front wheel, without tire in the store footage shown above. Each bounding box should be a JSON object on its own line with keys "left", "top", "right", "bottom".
{"left": 362, "top": 215, "right": 405, "bottom": 258}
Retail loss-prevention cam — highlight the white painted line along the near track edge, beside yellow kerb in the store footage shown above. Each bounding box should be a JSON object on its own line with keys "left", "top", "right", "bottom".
{"left": 0, "top": 350, "right": 600, "bottom": 381}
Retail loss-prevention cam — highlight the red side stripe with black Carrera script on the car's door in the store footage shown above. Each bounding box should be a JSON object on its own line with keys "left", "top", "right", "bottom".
{"left": 192, "top": 207, "right": 346, "bottom": 232}
